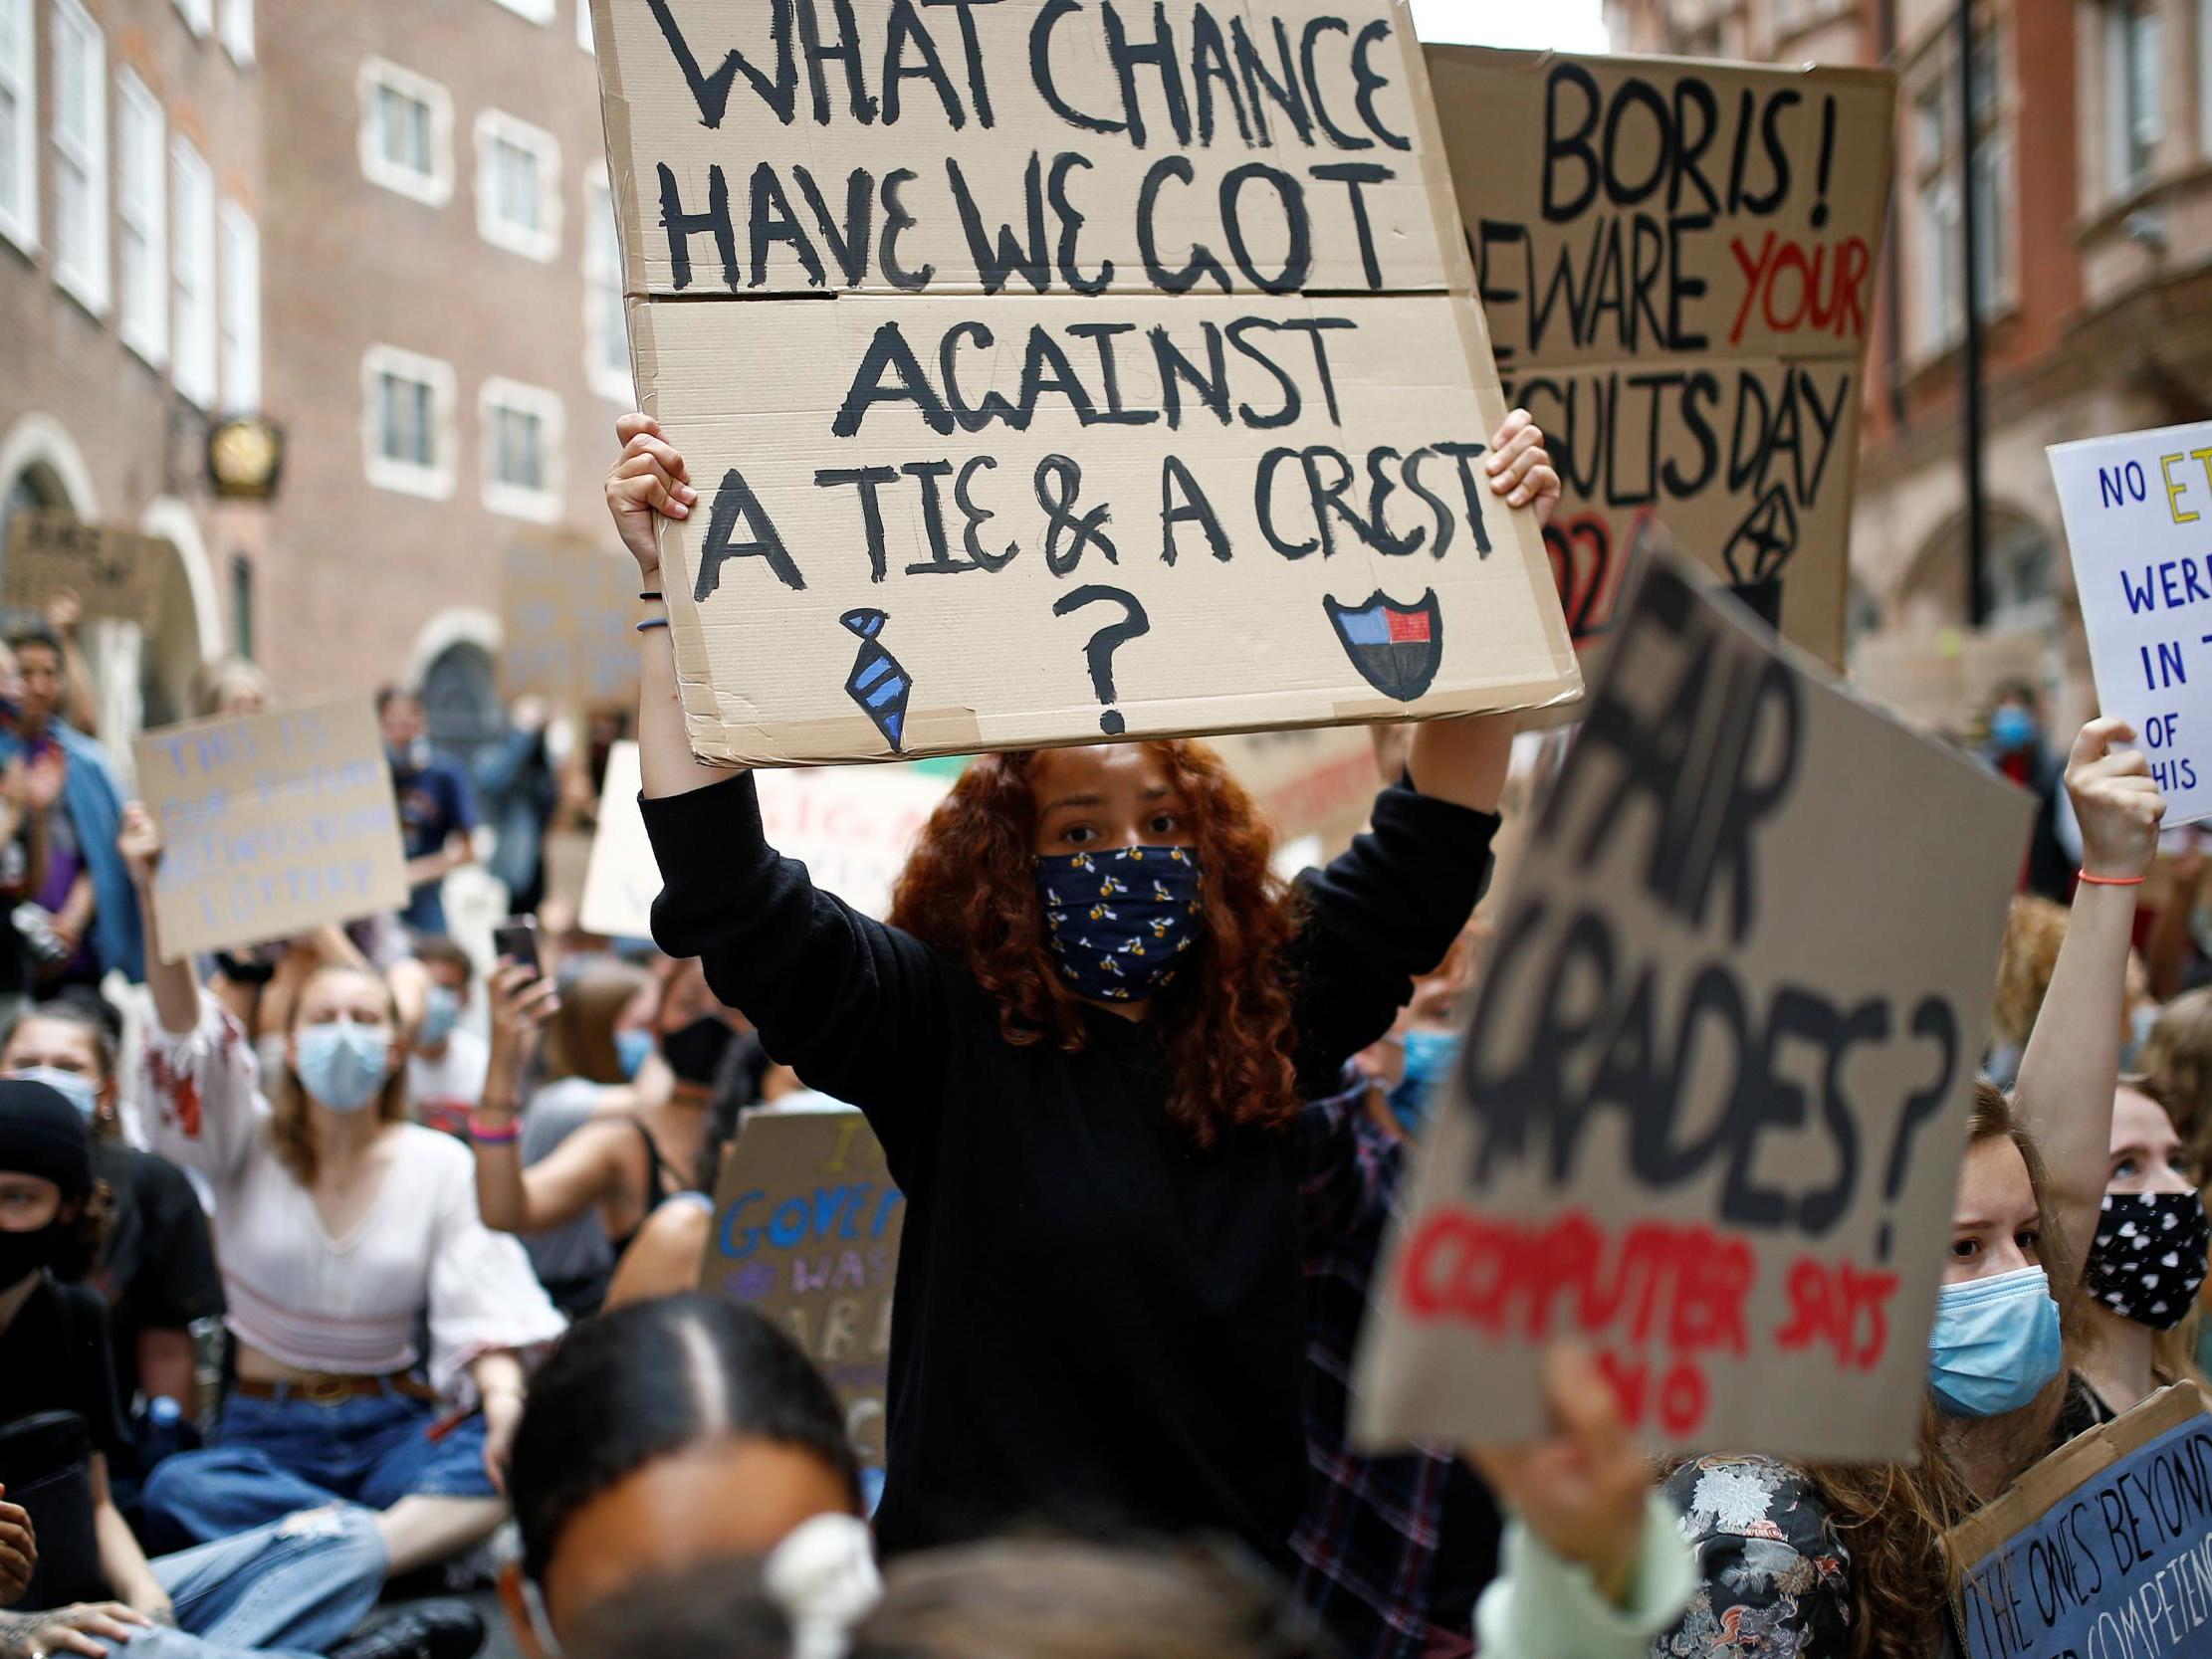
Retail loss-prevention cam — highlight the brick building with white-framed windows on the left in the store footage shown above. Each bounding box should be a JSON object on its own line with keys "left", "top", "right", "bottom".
{"left": 0, "top": 0, "right": 632, "bottom": 765}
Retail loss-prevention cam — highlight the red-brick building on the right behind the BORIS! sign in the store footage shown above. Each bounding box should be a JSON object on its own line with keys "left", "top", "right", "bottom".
{"left": 1608, "top": 0, "right": 2212, "bottom": 729}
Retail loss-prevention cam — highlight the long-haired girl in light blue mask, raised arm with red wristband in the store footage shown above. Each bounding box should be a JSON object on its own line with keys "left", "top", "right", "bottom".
{"left": 1653, "top": 719, "right": 2165, "bottom": 1659}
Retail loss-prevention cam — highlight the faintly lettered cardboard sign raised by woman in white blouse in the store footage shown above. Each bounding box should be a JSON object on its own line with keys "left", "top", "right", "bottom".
{"left": 130, "top": 697, "right": 407, "bottom": 962}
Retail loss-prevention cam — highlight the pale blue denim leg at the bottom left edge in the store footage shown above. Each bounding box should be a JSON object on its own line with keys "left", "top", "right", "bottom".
{"left": 96, "top": 1504, "right": 385, "bottom": 1659}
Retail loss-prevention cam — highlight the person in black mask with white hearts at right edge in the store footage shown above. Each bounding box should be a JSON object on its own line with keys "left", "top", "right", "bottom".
{"left": 2082, "top": 1084, "right": 2212, "bottom": 1416}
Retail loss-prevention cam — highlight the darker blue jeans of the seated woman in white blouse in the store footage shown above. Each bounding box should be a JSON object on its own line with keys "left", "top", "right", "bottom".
{"left": 143, "top": 1393, "right": 498, "bottom": 1544}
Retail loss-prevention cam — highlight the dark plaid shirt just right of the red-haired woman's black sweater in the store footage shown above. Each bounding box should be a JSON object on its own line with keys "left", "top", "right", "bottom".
{"left": 1292, "top": 1073, "right": 1502, "bottom": 1659}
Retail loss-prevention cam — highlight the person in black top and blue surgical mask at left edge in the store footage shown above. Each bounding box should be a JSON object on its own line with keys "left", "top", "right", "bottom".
{"left": 0, "top": 997, "right": 223, "bottom": 1486}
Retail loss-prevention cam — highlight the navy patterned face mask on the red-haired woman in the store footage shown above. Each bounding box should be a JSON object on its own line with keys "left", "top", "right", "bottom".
{"left": 1037, "top": 847, "right": 1206, "bottom": 1002}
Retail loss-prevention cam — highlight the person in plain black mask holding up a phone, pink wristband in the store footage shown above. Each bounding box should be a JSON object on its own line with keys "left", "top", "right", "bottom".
{"left": 471, "top": 962, "right": 739, "bottom": 1316}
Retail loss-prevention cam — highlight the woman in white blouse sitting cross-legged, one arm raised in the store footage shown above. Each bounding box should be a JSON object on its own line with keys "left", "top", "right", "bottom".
{"left": 119, "top": 803, "right": 561, "bottom": 1572}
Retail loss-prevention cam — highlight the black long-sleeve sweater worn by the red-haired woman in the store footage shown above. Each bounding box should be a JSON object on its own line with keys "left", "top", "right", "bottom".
{"left": 646, "top": 774, "right": 1497, "bottom": 1566}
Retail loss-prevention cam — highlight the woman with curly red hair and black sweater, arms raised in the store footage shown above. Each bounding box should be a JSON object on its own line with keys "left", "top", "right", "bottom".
{"left": 606, "top": 414, "right": 1560, "bottom": 1563}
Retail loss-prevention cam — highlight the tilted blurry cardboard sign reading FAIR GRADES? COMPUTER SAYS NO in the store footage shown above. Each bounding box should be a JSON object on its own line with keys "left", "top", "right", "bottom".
{"left": 1358, "top": 559, "right": 2033, "bottom": 1460}
